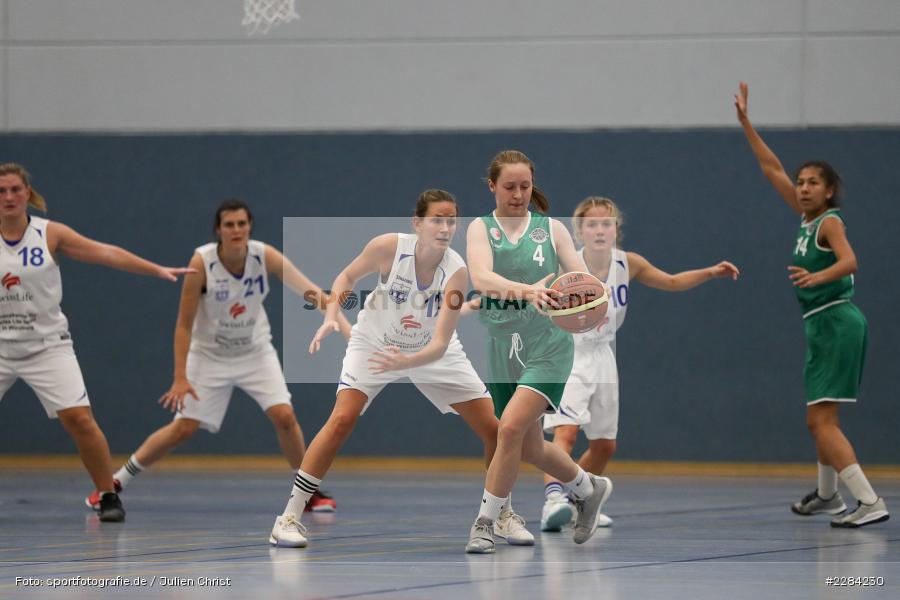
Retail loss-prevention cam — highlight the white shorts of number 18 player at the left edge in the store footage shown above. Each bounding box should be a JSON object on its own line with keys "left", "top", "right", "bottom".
{"left": 0, "top": 341, "right": 91, "bottom": 419}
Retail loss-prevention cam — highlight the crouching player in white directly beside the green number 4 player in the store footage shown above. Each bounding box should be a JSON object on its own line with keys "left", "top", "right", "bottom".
{"left": 269, "top": 190, "right": 534, "bottom": 548}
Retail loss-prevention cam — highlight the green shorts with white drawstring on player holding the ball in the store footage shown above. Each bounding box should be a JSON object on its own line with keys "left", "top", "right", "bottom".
{"left": 487, "top": 323, "right": 575, "bottom": 418}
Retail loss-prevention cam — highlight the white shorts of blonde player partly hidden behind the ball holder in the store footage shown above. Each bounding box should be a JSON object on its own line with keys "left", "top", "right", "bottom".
{"left": 544, "top": 344, "right": 619, "bottom": 440}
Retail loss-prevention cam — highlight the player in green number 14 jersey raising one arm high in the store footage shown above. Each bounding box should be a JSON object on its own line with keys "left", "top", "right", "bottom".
{"left": 734, "top": 83, "right": 890, "bottom": 527}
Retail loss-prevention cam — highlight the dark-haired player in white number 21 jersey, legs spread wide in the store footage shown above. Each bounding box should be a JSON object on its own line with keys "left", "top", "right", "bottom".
{"left": 85, "top": 200, "right": 350, "bottom": 512}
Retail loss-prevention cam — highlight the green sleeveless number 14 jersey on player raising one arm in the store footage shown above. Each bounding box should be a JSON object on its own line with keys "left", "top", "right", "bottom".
{"left": 793, "top": 208, "right": 853, "bottom": 318}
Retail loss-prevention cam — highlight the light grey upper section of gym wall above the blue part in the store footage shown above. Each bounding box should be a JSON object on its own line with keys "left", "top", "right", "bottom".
{"left": 0, "top": 0, "right": 900, "bottom": 131}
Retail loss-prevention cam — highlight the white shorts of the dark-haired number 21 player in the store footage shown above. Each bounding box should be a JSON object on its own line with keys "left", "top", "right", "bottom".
{"left": 175, "top": 344, "right": 291, "bottom": 433}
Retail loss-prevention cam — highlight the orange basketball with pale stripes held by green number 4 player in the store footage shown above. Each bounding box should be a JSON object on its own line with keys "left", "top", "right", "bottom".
{"left": 547, "top": 271, "right": 609, "bottom": 333}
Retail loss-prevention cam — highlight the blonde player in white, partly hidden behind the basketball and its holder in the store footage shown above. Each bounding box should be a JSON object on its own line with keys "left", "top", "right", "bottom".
{"left": 541, "top": 196, "right": 738, "bottom": 531}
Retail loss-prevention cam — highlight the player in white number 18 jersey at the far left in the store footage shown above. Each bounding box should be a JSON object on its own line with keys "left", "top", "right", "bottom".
{"left": 0, "top": 163, "right": 193, "bottom": 521}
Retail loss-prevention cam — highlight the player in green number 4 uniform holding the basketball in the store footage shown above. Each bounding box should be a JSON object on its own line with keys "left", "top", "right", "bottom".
{"left": 466, "top": 150, "right": 612, "bottom": 554}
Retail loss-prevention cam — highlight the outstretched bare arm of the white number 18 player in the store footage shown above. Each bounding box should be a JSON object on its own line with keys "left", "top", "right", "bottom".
{"left": 47, "top": 221, "right": 196, "bottom": 281}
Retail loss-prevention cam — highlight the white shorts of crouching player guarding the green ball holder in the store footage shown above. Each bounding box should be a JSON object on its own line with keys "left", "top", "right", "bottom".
{"left": 337, "top": 332, "right": 491, "bottom": 414}
